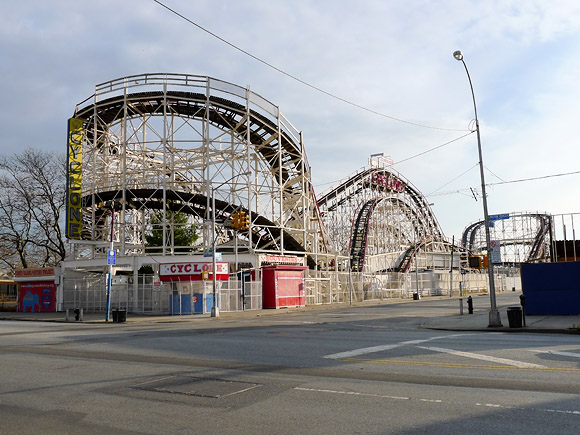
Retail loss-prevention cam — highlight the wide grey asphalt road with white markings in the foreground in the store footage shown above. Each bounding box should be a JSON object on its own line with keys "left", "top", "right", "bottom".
{"left": 0, "top": 300, "right": 580, "bottom": 434}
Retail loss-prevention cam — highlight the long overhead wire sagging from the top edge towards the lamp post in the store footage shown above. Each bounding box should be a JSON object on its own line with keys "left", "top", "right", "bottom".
{"left": 153, "top": 0, "right": 465, "bottom": 131}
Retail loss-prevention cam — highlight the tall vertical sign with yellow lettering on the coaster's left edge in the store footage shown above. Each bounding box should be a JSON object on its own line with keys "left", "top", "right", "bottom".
{"left": 65, "top": 118, "right": 83, "bottom": 239}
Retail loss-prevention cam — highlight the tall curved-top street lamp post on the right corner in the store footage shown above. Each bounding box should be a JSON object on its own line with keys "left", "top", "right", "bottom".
{"left": 453, "top": 50, "right": 502, "bottom": 327}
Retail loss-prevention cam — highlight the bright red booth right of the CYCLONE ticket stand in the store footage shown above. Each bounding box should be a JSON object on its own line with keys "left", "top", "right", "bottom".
{"left": 262, "top": 265, "right": 308, "bottom": 308}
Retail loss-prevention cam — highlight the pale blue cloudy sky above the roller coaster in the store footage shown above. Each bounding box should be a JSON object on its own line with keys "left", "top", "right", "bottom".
{"left": 0, "top": 0, "right": 580, "bottom": 238}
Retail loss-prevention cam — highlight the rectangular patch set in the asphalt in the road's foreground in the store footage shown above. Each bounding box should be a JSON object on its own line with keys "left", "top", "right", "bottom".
{"left": 133, "top": 375, "right": 262, "bottom": 399}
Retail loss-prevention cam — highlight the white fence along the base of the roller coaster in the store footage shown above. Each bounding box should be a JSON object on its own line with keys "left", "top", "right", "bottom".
{"left": 62, "top": 270, "right": 521, "bottom": 314}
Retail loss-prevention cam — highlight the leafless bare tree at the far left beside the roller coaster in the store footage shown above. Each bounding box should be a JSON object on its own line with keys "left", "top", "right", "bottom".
{"left": 0, "top": 149, "right": 66, "bottom": 271}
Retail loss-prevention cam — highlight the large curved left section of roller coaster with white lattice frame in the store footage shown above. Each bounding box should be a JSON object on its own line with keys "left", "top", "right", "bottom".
{"left": 73, "top": 74, "right": 327, "bottom": 267}
